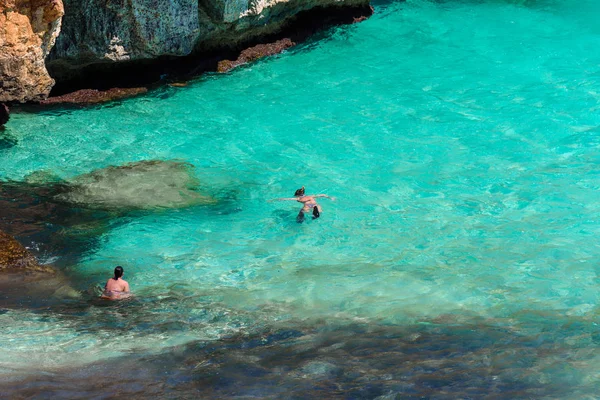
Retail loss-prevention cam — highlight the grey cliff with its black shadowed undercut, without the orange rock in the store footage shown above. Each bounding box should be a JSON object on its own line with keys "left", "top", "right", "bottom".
{"left": 47, "top": 0, "right": 371, "bottom": 94}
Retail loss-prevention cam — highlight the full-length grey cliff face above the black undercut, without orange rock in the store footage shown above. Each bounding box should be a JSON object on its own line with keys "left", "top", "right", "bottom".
{"left": 48, "top": 0, "right": 369, "bottom": 65}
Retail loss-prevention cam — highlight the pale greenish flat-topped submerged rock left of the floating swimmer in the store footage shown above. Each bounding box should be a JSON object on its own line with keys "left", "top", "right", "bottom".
{"left": 55, "top": 160, "right": 216, "bottom": 210}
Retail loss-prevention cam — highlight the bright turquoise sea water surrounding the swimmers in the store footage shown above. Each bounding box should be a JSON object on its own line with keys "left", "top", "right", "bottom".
{"left": 0, "top": 0, "right": 600, "bottom": 398}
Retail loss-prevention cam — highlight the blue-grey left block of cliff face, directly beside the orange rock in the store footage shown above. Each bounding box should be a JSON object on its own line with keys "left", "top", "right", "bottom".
{"left": 52, "top": 0, "right": 199, "bottom": 63}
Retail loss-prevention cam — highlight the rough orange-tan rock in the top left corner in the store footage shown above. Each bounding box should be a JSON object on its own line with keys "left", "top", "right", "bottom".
{"left": 0, "top": 0, "right": 64, "bottom": 102}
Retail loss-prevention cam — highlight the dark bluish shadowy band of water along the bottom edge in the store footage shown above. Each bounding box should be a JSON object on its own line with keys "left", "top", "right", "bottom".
{"left": 0, "top": 308, "right": 597, "bottom": 399}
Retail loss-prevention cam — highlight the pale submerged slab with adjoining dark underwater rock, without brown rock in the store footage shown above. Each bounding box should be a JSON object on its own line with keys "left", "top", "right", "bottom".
{"left": 0, "top": 160, "right": 221, "bottom": 267}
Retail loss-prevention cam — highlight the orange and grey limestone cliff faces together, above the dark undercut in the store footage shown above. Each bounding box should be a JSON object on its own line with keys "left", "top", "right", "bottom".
{"left": 0, "top": 0, "right": 369, "bottom": 103}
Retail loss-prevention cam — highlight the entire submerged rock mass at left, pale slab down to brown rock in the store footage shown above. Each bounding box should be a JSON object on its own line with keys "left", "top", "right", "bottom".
{"left": 0, "top": 160, "right": 217, "bottom": 308}
